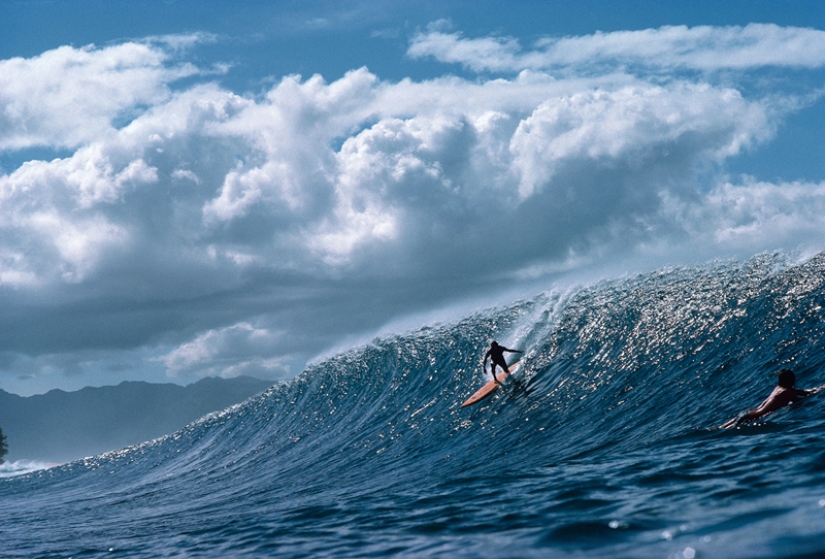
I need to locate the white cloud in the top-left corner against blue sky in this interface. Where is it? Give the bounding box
[0,42,197,150]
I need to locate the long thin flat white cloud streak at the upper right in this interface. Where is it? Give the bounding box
[407,23,825,72]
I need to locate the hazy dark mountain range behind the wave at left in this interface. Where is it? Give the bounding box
[0,377,273,462]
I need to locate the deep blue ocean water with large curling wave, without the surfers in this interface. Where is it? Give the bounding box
[0,254,825,559]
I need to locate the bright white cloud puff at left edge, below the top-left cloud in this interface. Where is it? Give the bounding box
[0,144,150,285]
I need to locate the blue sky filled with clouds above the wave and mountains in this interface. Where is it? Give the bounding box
[0,0,825,395]
